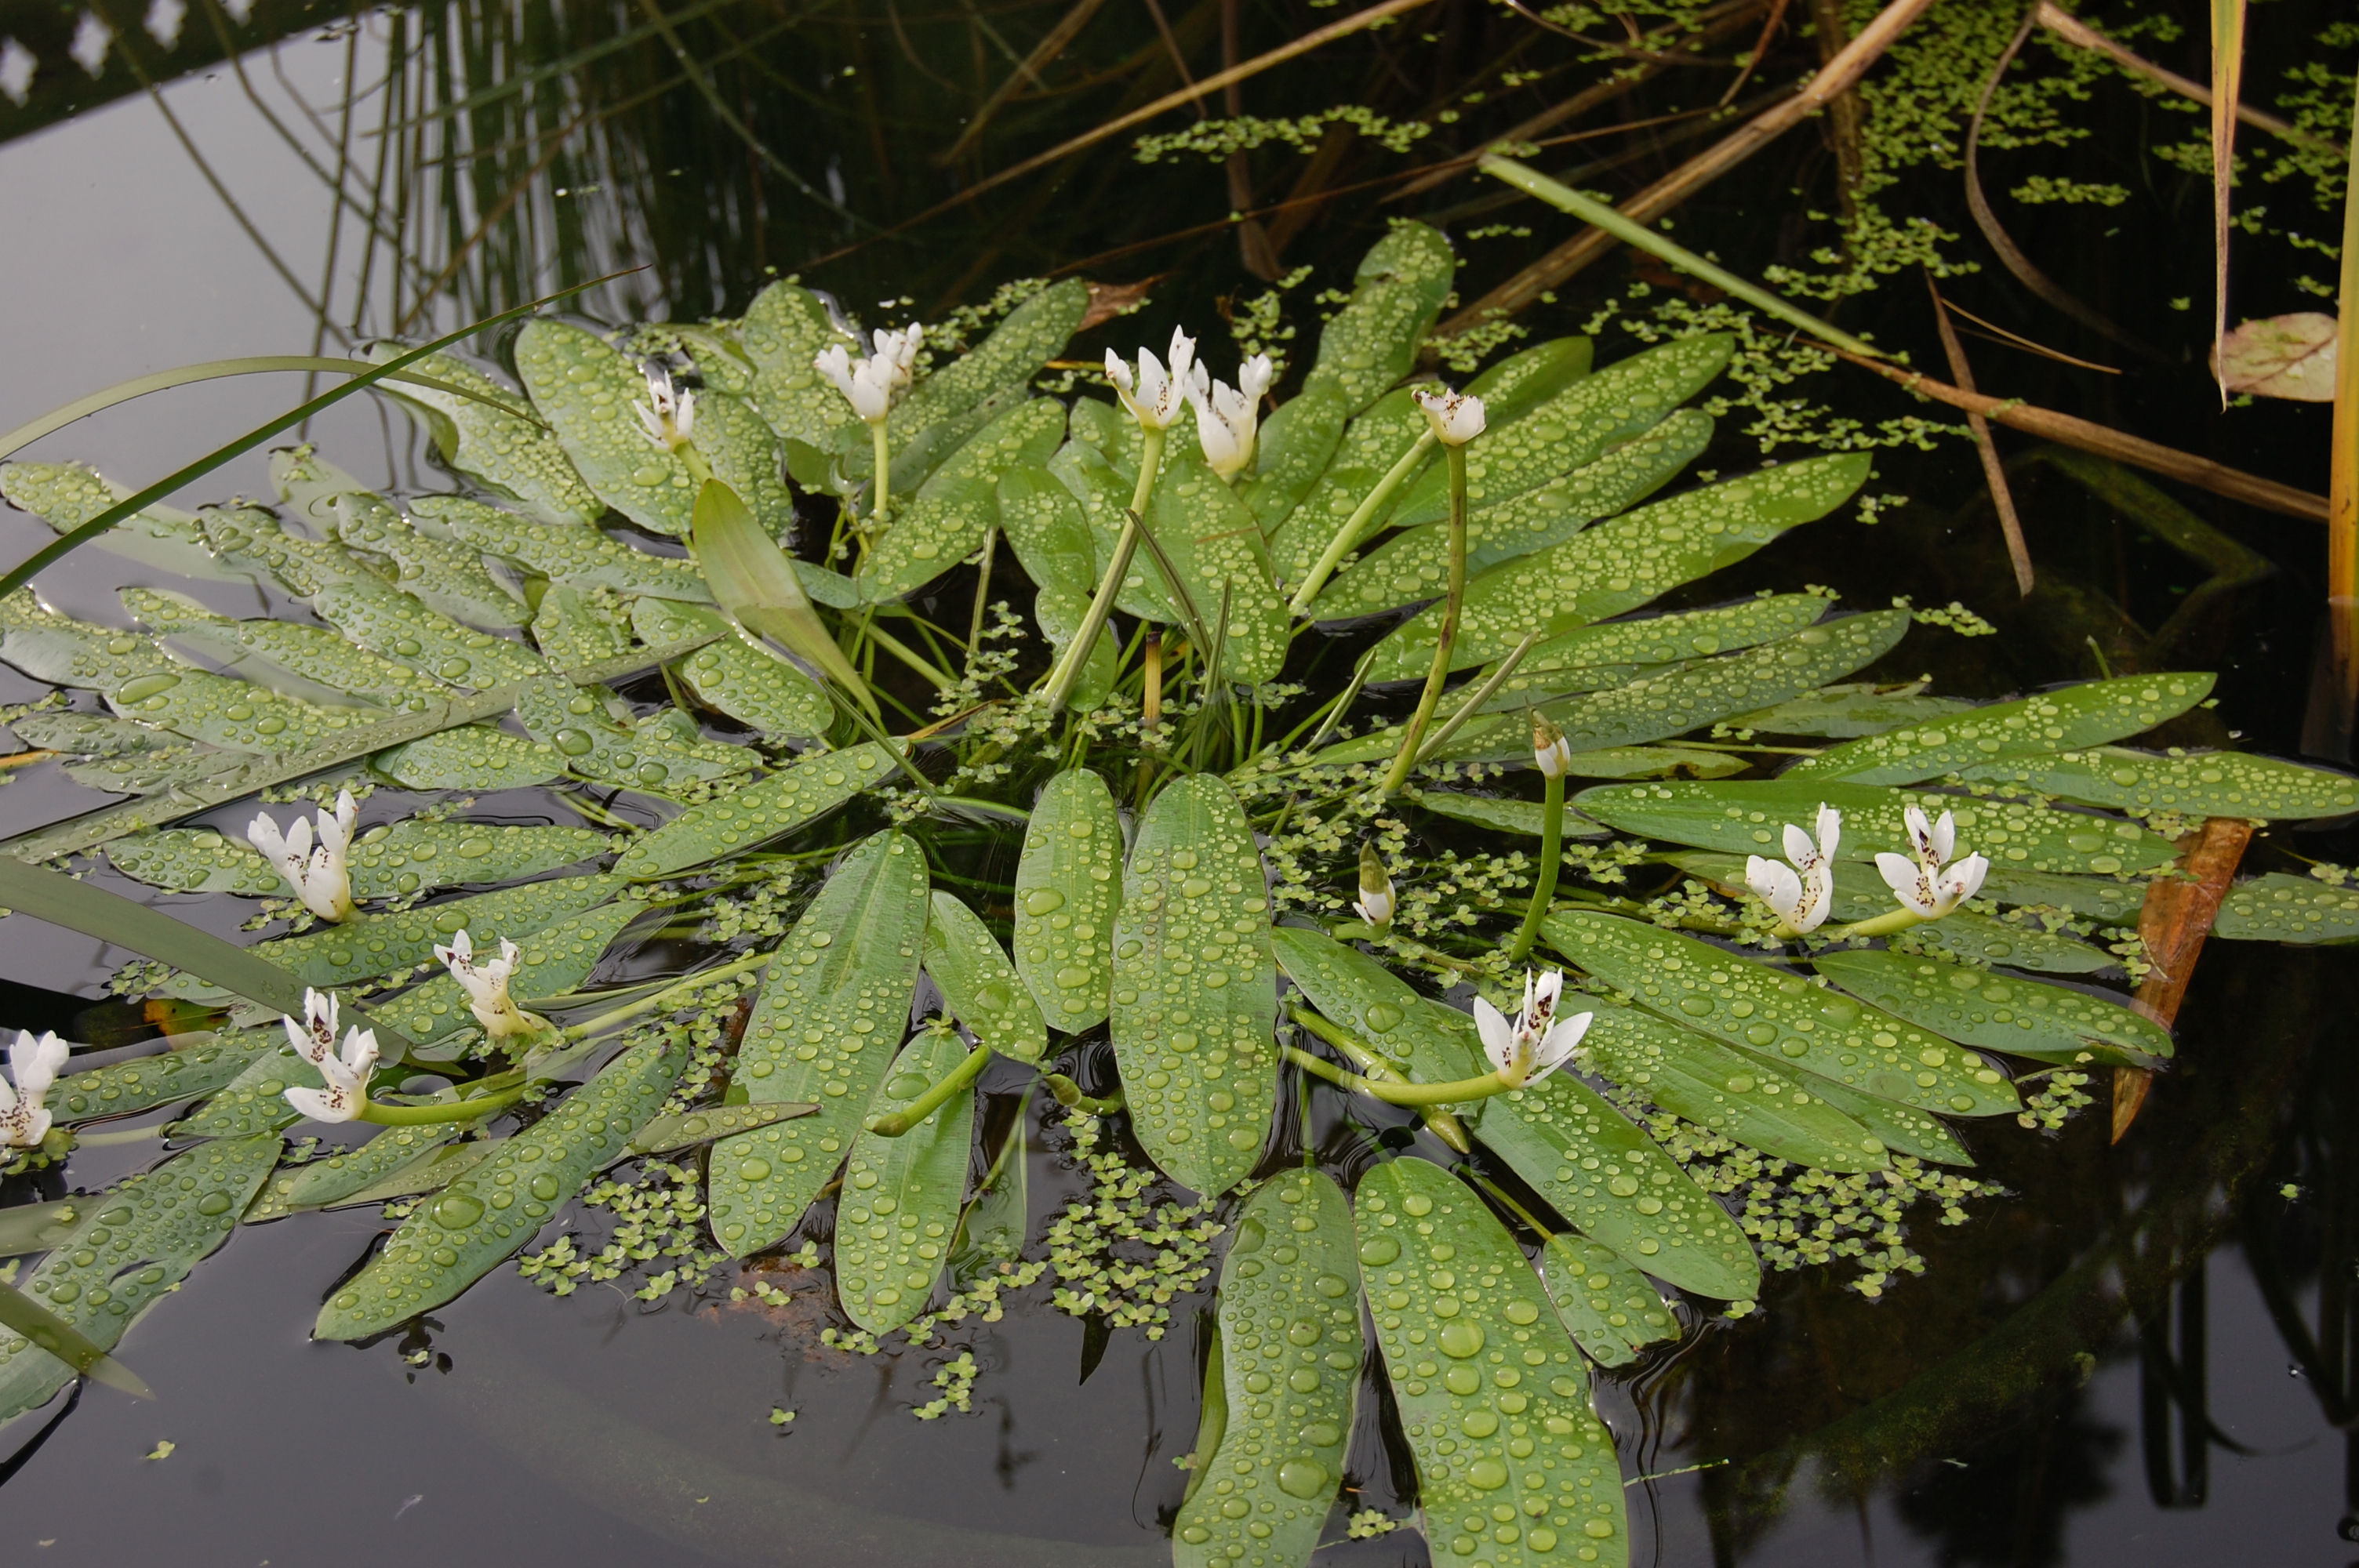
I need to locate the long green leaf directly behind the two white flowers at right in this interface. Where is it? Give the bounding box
[1573,778,2177,891]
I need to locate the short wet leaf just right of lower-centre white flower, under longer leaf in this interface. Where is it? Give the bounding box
[1580,1002,1892,1172]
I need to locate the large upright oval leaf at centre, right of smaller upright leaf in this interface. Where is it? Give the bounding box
[1111,773,1278,1196]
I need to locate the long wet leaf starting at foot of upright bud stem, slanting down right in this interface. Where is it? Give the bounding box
[1543,910,2019,1117]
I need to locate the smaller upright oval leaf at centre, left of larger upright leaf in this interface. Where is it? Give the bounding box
[1014,768,1123,1035]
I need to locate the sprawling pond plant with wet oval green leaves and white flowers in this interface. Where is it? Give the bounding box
[0,224,2359,1568]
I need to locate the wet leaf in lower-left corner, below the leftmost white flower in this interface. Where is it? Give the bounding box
[0,1139,278,1420]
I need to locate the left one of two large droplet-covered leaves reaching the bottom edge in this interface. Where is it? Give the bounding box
[1172,1170,1366,1568]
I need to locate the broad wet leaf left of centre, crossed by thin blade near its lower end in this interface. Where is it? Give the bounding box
[710,830,929,1257]
